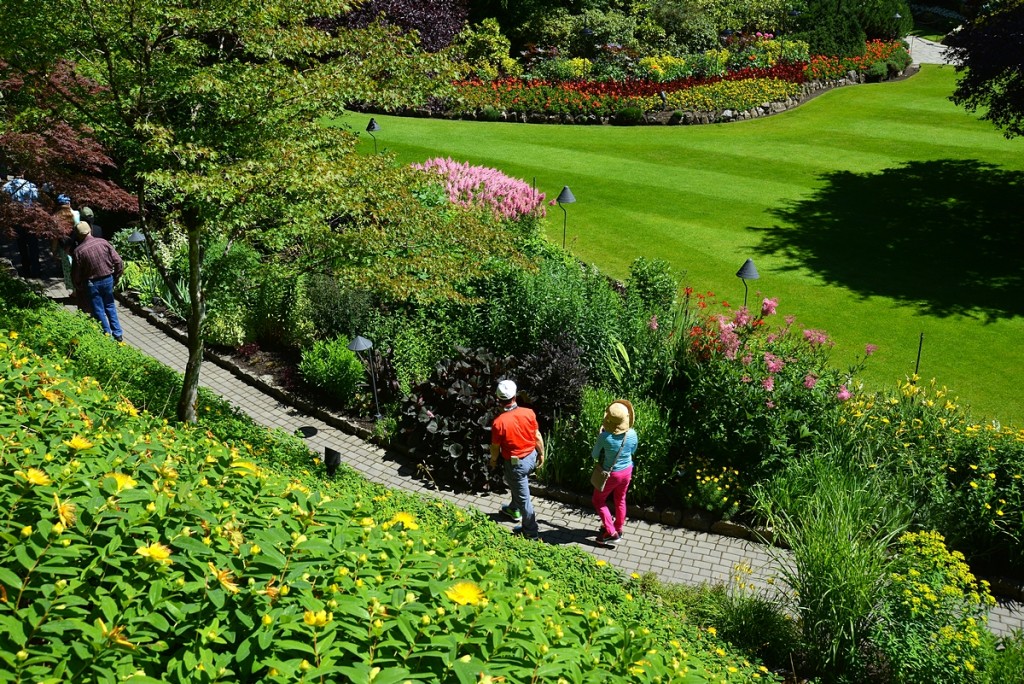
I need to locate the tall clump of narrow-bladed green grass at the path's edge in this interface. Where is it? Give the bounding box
[754,455,909,682]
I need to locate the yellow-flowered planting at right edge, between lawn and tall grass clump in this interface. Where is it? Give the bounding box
[843,378,1024,571]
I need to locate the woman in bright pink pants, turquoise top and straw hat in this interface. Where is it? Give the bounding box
[591,399,638,548]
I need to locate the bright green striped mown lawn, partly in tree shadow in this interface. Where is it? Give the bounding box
[351,67,1024,425]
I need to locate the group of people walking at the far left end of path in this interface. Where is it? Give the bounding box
[0,173,124,342]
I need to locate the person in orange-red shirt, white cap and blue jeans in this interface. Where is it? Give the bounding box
[490,380,544,540]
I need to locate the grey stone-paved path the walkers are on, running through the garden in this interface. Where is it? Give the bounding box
[16,268,1024,634]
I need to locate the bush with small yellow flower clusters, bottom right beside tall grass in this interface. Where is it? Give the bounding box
[870,531,1001,684]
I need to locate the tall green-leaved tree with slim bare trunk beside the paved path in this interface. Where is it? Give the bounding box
[0,0,444,421]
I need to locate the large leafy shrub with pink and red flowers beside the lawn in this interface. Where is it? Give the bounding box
[664,292,874,483]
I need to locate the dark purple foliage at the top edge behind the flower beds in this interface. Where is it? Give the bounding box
[315,0,469,52]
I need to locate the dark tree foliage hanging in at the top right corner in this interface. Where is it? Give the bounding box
[946,0,1024,138]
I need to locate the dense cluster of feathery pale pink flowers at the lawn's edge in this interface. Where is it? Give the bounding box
[413,158,547,221]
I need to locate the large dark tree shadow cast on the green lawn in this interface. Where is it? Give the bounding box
[749,160,1024,322]
